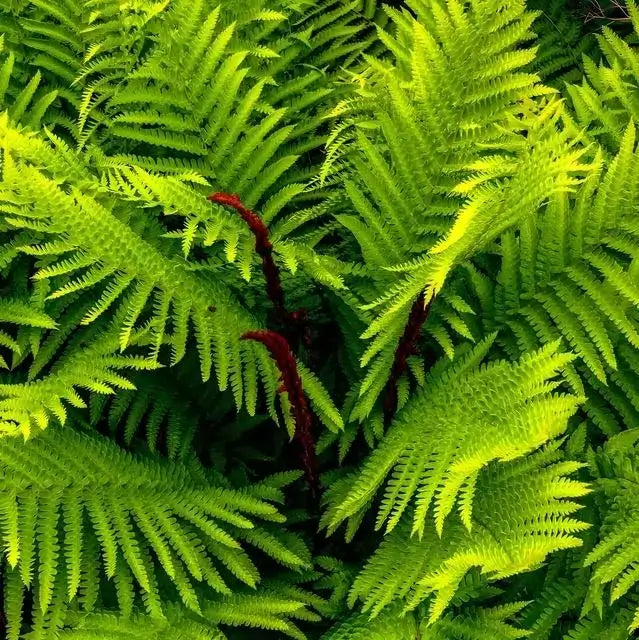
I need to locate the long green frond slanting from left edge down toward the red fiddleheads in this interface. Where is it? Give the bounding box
[2,120,292,418]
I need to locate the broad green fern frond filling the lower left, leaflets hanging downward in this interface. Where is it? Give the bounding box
[0,429,306,612]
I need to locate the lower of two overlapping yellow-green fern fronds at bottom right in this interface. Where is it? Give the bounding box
[349,448,589,623]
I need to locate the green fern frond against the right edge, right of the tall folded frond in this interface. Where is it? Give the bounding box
[476,125,637,420]
